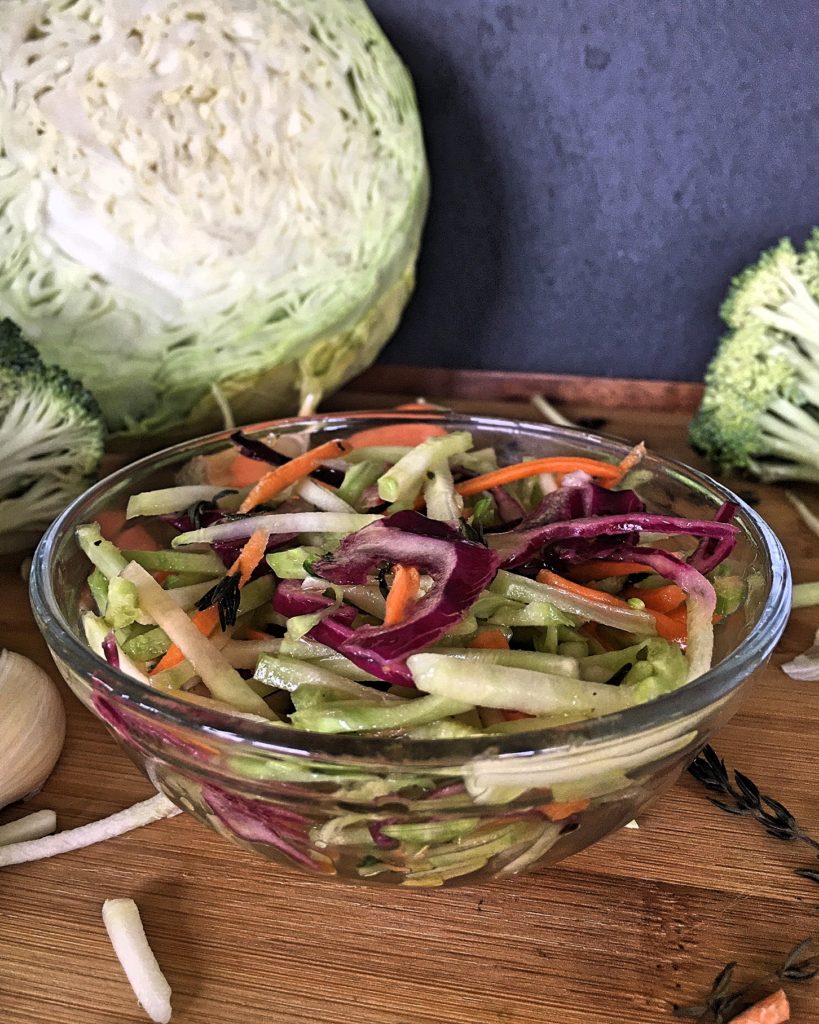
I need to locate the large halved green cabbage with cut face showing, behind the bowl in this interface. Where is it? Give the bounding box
[0,0,428,439]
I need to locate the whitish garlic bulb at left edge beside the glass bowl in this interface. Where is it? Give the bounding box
[0,650,66,808]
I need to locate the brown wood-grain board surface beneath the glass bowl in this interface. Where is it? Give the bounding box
[0,378,819,1024]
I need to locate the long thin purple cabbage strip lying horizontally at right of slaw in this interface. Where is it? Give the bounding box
[489,509,736,568]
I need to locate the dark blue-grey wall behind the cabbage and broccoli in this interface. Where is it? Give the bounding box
[371,0,819,380]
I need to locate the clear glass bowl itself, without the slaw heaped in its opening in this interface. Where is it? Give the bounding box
[31,413,790,887]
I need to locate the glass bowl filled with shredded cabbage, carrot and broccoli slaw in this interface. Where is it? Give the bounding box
[32,410,789,887]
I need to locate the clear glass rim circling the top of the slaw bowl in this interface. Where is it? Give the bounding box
[30,407,790,764]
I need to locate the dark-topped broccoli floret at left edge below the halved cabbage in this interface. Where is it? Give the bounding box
[0,321,105,551]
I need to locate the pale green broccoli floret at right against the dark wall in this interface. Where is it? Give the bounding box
[690,231,819,481]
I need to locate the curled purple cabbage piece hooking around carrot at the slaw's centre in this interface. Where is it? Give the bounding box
[312,512,500,682]
